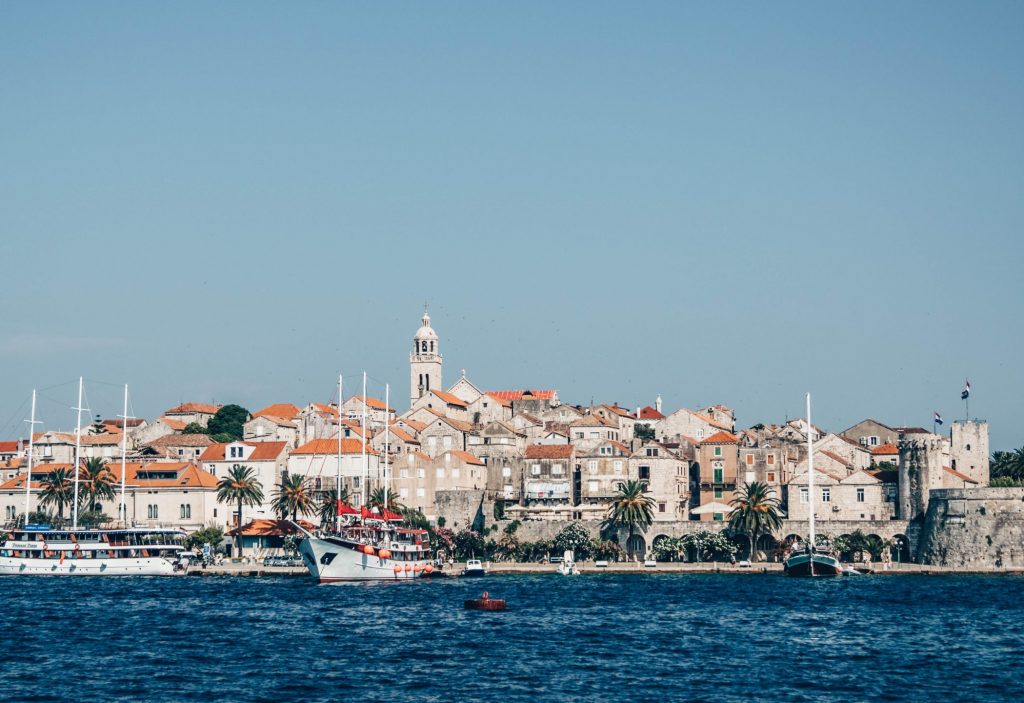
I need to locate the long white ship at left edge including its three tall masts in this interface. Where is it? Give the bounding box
[0,379,187,576]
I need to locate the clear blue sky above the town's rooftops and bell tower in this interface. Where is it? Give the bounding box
[0,1,1024,449]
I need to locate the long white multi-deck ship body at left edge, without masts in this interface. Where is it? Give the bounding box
[0,525,190,576]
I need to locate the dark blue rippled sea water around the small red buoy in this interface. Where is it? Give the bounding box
[0,574,1024,703]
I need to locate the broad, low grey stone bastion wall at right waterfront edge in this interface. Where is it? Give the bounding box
[916,488,1024,569]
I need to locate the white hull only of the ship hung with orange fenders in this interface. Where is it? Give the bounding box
[299,537,433,583]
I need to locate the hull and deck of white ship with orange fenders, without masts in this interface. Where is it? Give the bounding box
[299,520,435,583]
